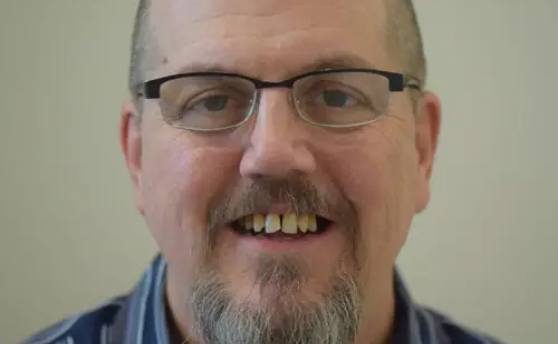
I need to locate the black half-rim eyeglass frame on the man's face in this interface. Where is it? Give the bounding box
[138,68,422,132]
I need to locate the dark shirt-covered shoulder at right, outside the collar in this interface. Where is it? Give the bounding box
[417,307,503,344]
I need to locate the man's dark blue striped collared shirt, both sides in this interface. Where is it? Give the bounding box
[23,255,506,344]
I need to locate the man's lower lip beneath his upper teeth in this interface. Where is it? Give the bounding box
[226,223,336,251]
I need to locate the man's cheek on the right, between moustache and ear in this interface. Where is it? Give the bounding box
[324,130,418,266]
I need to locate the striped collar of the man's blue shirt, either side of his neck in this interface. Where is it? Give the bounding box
[127,255,430,344]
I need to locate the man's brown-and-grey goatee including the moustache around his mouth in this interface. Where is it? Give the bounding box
[188,176,360,344]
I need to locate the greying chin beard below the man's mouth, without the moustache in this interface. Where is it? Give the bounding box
[190,256,360,344]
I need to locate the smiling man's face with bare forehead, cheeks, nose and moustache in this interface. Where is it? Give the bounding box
[124,0,437,340]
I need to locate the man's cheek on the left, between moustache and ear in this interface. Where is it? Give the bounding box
[141,129,239,266]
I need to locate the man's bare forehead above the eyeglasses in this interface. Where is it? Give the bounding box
[151,0,393,80]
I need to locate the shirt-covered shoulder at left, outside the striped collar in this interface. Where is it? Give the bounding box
[21,296,127,344]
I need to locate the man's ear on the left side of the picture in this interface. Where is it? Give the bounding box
[120,101,144,215]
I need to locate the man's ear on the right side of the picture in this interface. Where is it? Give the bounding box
[415,92,441,213]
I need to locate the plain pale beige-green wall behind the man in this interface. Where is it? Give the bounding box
[0,0,558,343]
